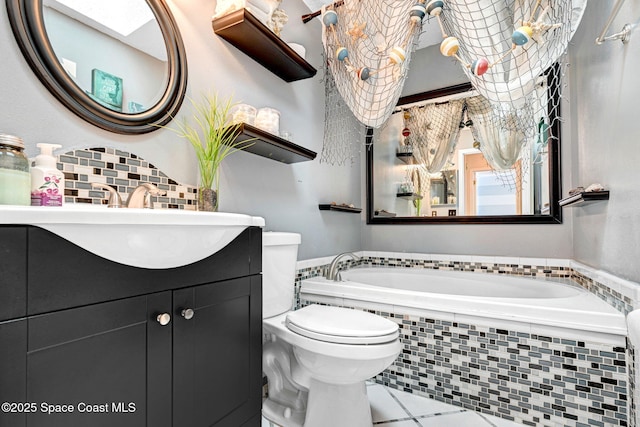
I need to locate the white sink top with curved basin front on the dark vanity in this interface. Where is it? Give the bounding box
[0,205,264,268]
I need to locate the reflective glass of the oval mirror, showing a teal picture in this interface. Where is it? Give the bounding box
[43,0,169,114]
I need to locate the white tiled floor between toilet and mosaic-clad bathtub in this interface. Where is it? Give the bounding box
[262,383,519,427]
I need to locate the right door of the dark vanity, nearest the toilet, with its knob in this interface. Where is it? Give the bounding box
[173,276,262,427]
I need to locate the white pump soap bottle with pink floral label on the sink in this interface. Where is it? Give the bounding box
[31,143,64,206]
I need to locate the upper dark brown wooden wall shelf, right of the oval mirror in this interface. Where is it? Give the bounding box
[212,9,317,82]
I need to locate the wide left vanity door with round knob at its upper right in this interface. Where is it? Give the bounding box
[26,292,172,427]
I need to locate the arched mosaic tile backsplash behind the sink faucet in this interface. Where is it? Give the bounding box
[56,147,198,210]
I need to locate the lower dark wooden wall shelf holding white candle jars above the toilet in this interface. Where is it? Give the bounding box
[236,123,317,163]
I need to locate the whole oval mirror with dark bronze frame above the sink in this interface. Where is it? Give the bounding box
[6,0,187,134]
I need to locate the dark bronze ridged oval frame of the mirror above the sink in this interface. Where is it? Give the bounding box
[6,0,187,134]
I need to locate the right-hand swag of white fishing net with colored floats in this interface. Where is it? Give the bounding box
[427,0,586,108]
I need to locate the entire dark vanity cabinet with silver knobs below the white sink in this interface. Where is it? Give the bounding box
[0,226,262,427]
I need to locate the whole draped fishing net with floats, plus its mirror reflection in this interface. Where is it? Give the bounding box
[322,0,586,171]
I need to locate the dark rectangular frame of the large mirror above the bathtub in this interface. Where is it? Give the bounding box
[365,65,562,225]
